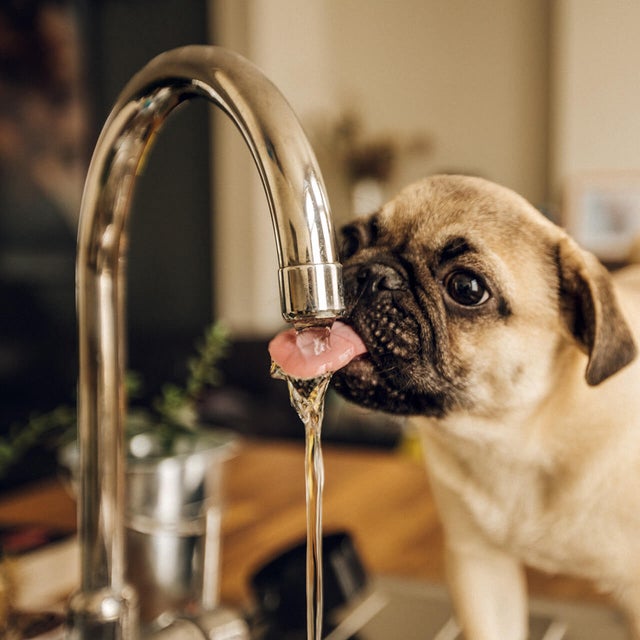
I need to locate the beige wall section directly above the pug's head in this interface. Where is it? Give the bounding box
[327,0,548,203]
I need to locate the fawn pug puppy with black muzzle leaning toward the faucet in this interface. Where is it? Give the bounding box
[334,176,640,640]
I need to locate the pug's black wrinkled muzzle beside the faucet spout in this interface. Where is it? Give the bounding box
[333,256,456,415]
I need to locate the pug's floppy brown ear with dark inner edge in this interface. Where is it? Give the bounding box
[558,237,637,385]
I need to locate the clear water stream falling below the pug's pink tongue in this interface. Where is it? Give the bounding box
[271,363,331,640]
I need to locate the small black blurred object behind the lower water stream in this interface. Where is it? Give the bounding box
[251,532,367,640]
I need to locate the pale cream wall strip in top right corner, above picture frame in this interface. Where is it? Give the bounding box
[550,0,640,198]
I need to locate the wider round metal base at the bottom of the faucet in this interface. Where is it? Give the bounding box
[66,587,139,640]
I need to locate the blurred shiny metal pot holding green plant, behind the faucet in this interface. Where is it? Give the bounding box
[61,428,237,627]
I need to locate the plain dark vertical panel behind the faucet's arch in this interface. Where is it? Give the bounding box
[74,0,215,362]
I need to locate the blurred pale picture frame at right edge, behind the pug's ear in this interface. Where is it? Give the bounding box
[561,170,640,264]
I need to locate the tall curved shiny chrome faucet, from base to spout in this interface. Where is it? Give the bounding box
[67,46,343,640]
